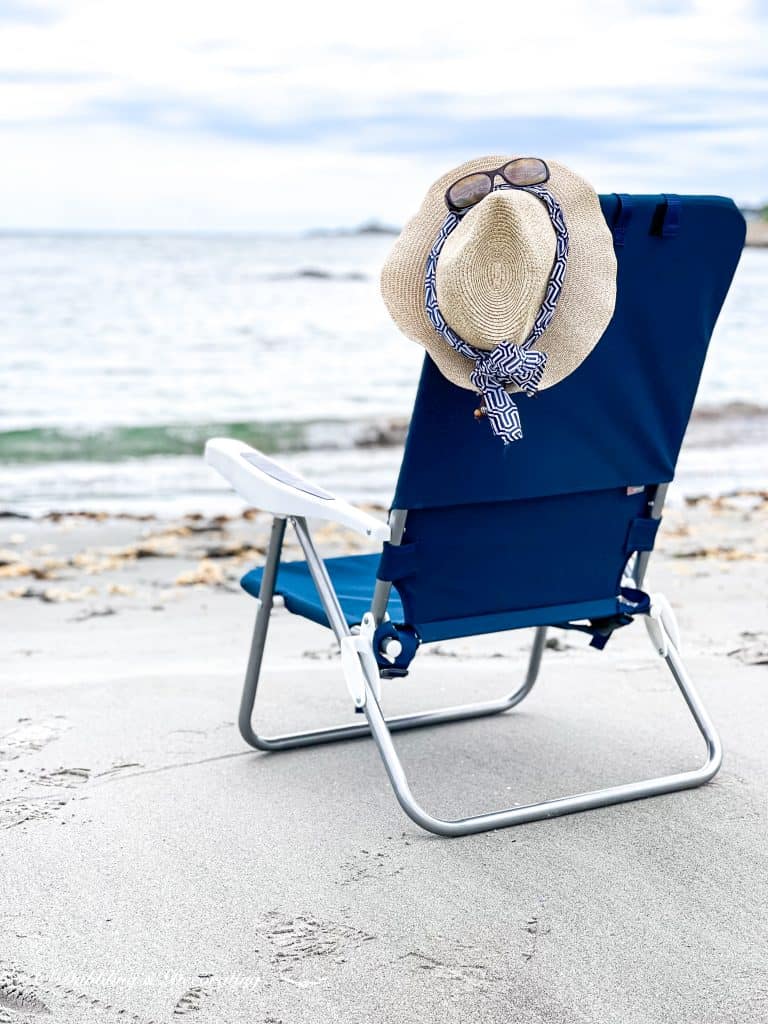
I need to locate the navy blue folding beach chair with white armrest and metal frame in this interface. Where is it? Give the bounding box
[206,195,744,836]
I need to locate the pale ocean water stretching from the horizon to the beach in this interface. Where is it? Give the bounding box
[0,232,768,515]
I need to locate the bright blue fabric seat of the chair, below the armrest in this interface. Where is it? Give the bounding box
[240,555,403,628]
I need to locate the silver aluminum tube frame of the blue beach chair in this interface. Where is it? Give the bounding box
[239,499,722,837]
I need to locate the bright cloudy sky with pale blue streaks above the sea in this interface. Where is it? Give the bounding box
[0,0,768,231]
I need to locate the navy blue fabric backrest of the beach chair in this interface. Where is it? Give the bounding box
[379,196,744,639]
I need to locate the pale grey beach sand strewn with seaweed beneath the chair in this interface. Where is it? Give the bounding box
[0,493,768,1024]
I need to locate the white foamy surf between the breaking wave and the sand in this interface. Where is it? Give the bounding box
[0,402,768,519]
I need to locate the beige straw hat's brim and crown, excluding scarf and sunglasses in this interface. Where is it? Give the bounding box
[381,156,616,391]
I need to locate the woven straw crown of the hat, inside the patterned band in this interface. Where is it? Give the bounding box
[436,189,556,349]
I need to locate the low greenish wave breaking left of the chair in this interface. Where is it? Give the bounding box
[0,419,408,465]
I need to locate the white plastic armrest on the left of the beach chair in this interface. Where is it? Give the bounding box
[205,437,390,541]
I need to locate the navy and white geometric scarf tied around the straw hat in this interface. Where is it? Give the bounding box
[424,184,568,444]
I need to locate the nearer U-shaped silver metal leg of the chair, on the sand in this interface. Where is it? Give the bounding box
[366,626,723,836]
